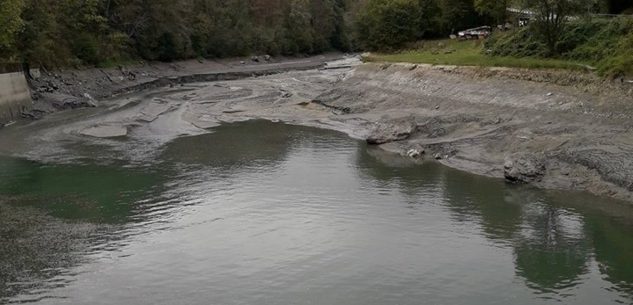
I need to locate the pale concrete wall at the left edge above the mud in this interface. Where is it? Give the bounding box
[0,72,32,126]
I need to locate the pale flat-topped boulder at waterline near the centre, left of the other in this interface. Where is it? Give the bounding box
[367,117,417,145]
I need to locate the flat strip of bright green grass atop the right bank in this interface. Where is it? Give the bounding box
[364,40,587,70]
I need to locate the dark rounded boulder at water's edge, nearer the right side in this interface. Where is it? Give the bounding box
[503,153,545,183]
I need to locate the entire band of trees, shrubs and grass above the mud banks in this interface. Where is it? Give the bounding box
[0,0,633,76]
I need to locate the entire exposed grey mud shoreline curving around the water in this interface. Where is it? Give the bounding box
[0,54,633,202]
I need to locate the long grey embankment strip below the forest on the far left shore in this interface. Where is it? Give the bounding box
[24,53,342,118]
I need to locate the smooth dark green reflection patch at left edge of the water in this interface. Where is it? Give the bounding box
[0,158,162,223]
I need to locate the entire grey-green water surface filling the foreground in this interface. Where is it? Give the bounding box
[0,122,633,305]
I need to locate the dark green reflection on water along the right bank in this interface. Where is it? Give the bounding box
[358,147,633,302]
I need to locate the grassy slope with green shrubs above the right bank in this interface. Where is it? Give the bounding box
[365,18,633,78]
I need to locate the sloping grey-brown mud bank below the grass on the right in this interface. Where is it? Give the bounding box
[318,64,633,200]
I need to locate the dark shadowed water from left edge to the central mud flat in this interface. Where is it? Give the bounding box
[0,121,338,302]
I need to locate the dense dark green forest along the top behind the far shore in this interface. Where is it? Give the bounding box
[0,0,630,67]
